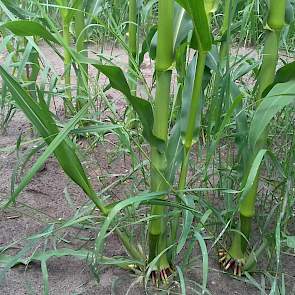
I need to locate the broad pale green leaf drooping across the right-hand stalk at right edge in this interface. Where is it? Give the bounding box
[249,81,295,148]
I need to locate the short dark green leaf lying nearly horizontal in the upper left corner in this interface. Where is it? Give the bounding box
[2,20,59,44]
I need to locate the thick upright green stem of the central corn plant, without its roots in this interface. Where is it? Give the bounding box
[149,0,174,270]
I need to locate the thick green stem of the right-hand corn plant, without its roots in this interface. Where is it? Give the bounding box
[230,0,286,264]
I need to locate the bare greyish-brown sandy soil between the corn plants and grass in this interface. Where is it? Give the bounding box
[0,48,295,295]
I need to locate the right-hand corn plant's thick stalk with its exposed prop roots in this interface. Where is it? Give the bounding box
[219,0,286,276]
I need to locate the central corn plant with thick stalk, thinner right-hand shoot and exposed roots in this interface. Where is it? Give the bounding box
[149,1,216,281]
